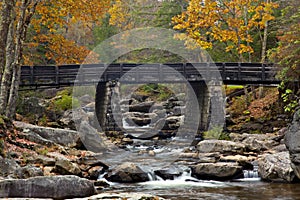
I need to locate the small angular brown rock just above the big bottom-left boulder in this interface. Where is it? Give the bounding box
[54,159,81,175]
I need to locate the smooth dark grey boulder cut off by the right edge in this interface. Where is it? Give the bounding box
[284,109,300,179]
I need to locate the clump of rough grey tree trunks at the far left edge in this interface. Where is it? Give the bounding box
[0,0,40,118]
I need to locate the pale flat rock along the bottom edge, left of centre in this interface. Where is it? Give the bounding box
[69,192,164,200]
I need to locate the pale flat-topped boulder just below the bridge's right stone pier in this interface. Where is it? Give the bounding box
[197,140,245,154]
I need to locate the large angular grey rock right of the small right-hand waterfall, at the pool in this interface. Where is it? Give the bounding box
[258,152,296,183]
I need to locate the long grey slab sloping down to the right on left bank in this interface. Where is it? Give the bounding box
[14,122,82,147]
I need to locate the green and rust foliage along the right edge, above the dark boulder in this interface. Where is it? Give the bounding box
[269,1,300,113]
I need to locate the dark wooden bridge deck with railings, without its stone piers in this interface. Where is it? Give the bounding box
[20,63,280,89]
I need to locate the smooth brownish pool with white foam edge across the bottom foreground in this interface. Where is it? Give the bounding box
[99,175,300,200]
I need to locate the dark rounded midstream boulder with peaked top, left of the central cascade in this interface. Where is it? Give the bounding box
[106,162,149,183]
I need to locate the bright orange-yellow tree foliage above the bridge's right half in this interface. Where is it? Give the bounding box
[173,0,277,61]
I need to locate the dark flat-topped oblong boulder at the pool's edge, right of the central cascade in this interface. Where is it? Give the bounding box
[191,162,243,181]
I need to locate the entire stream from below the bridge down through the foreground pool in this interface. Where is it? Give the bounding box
[95,120,300,200]
